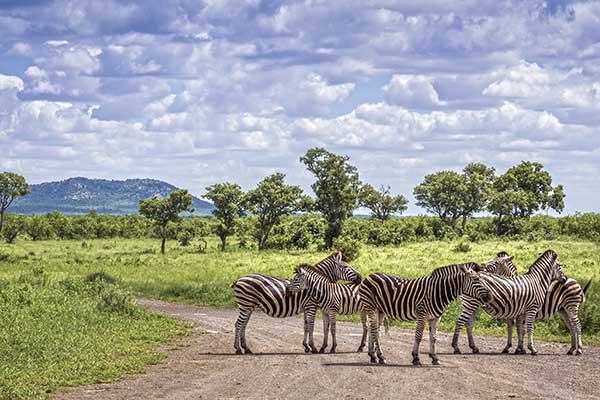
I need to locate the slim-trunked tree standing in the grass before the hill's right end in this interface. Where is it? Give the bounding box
[140,190,194,254]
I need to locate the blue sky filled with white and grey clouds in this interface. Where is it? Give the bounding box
[0,0,600,214]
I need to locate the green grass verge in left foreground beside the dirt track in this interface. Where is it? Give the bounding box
[0,270,188,400]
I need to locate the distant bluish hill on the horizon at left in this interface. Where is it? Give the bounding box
[9,178,214,215]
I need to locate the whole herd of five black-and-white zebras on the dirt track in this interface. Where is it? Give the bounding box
[232,250,591,365]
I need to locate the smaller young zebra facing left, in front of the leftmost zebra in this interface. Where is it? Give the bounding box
[287,264,367,353]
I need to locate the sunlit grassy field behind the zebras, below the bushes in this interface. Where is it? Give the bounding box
[0,234,600,344]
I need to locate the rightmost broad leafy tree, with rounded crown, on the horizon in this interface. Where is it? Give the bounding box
[488,161,565,234]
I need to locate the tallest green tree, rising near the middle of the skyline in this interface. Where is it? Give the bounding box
[300,148,361,248]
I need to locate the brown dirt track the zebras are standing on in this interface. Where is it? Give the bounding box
[56,300,600,400]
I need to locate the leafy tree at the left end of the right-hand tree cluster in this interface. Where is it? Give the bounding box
[413,171,466,228]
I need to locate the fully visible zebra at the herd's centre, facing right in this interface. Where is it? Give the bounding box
[359,263,490,365]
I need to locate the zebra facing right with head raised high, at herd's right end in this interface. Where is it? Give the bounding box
[468,250,567,355]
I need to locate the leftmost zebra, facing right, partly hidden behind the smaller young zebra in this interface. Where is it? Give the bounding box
[231,252,361,354]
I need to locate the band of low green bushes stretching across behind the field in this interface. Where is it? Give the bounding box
[2,211,600,249]
